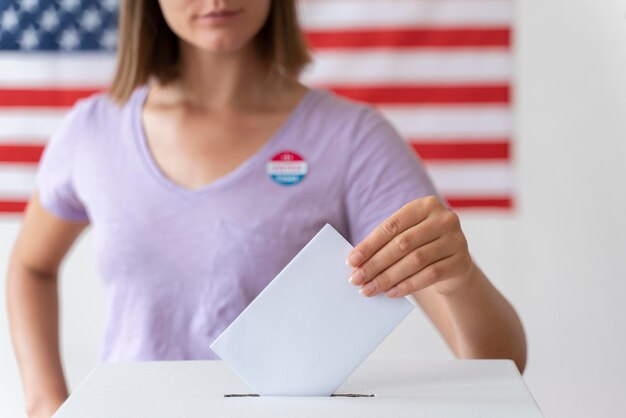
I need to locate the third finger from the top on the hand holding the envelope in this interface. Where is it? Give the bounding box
[359,238,454,296]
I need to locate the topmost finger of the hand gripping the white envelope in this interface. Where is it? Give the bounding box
[346,196,441,267]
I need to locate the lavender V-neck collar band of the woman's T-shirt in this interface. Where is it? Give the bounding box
[131,83,317,199]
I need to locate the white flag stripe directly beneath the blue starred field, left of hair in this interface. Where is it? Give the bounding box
[0,52,115,88]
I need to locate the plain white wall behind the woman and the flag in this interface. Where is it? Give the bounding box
[0,0,626,418]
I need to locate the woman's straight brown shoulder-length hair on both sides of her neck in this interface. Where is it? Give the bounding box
[108,0,311,104]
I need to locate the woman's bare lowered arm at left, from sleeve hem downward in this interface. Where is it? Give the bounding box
[7,194,88,418]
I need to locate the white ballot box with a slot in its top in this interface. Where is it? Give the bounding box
[54,359,542,418]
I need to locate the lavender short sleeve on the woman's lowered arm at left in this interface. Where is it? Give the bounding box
[35,102,89,222]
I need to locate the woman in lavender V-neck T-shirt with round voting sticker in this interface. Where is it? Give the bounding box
[8,0,526,417]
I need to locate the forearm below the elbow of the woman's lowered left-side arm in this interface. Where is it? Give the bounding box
[7,261,68,417]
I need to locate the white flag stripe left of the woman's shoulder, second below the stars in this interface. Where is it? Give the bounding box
[0,108,67,143]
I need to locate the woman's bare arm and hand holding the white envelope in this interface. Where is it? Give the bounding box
[347,196,526,371]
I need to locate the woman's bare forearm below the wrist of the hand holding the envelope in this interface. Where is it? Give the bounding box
[434,264,526,372]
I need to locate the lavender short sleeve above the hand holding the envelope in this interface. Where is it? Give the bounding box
[346,107,445,245]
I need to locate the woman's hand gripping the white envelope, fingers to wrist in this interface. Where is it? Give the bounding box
[346,196,474,297]
